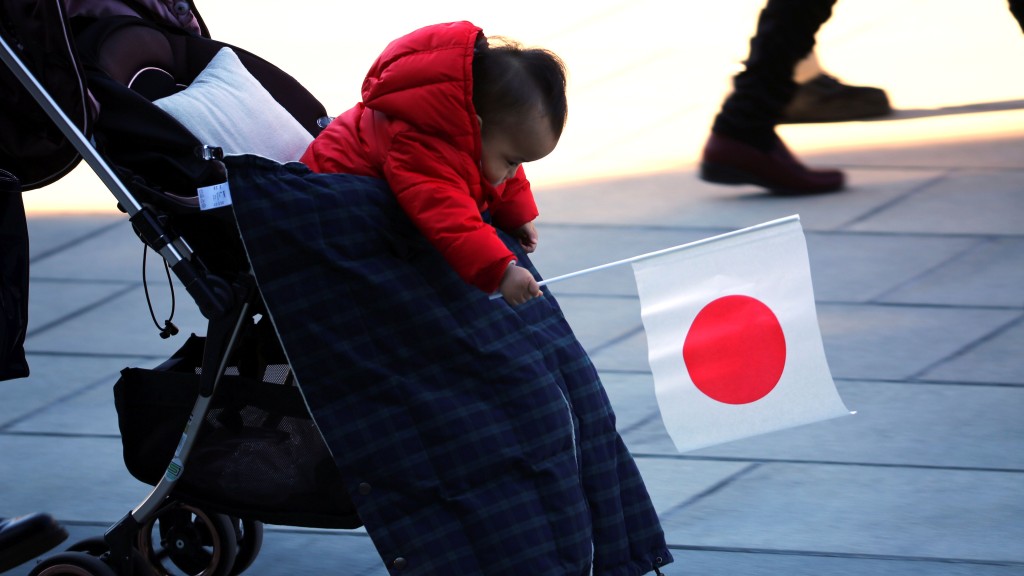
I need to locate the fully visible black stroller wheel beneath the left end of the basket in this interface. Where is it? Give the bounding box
[138,502,239,576]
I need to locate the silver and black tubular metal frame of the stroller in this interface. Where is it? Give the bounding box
[0,1,352,576]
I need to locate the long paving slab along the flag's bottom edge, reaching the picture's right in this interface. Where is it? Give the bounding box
[684,380,1024,472]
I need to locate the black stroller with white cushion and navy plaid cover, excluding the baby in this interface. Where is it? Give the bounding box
[0,0,671,576]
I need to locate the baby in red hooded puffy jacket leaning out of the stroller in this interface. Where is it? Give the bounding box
[302,22,567,304]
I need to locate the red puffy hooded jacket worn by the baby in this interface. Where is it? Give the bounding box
[302,22,538,292]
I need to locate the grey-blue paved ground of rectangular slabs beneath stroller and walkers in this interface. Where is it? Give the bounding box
[0,127,1024,576]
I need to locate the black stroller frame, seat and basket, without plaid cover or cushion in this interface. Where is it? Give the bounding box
[0,0,361,576]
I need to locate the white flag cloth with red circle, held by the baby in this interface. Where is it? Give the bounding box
[632,216,851,452]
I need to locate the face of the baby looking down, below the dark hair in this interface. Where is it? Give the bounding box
[480,114,558,187]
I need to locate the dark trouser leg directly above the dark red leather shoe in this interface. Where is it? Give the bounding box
[712,0,839,150]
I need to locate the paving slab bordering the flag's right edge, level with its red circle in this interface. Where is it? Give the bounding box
[817,303,1020,380]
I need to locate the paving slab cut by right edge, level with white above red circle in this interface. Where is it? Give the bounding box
[879,235,1024,307]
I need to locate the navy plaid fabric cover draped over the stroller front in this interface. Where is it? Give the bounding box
[225,157,671,576]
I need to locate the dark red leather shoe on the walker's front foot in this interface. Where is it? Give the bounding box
[700,134,846,195]
